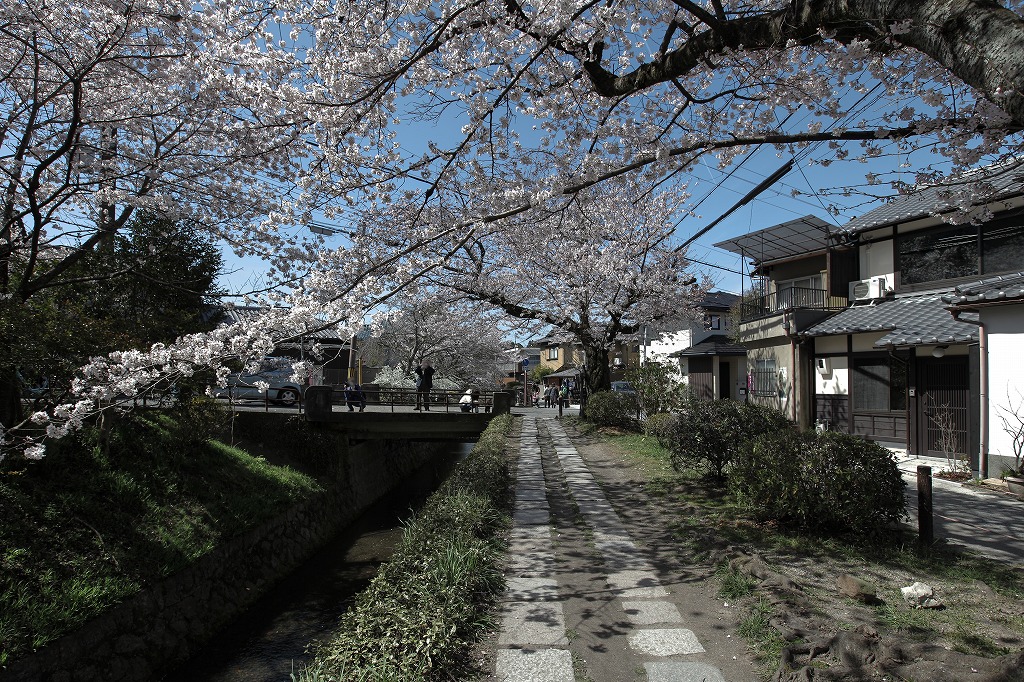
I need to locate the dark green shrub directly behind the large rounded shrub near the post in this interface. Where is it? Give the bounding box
[663,398,791,480]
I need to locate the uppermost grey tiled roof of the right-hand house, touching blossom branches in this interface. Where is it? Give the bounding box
[838,167,1024,235]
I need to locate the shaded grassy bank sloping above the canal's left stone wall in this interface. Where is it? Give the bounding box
[0,402,323,665]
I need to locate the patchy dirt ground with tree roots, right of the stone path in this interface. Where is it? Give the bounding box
[480,419,1024,682]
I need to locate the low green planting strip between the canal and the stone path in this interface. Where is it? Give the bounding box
[293,415,512,682]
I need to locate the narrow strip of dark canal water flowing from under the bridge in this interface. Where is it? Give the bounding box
[164,443,473,682]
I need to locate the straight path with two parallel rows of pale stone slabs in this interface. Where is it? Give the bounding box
[496,416,737,682]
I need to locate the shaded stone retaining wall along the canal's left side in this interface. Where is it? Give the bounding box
[0,414,445,682]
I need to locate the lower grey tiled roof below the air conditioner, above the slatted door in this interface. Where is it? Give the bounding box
[805,294,978,348]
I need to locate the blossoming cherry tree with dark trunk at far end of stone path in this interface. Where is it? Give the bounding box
[403,180,709,391]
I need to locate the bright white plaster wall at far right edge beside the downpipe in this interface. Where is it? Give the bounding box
[981,303,1024,458]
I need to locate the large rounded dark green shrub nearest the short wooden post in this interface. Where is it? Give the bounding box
[729,430,906,536]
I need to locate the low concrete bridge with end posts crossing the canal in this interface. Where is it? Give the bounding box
[304,386,512,440]
